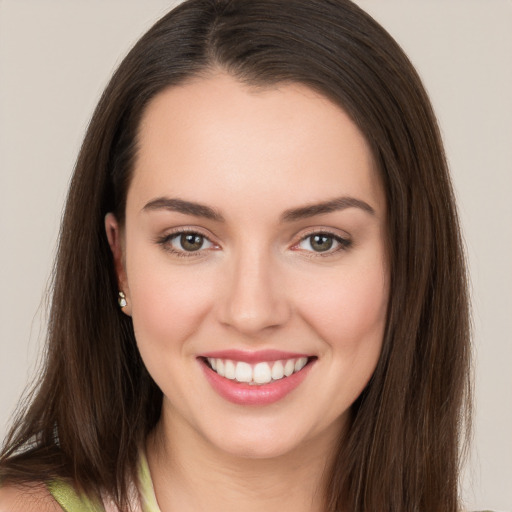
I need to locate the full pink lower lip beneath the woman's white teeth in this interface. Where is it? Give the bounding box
[198,359,315,405]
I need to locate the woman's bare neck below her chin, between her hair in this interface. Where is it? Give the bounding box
[147,406,339,512]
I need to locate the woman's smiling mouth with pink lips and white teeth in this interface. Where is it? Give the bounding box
[198,352,318,405]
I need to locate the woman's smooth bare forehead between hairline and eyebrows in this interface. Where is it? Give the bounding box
[128,74,383,216]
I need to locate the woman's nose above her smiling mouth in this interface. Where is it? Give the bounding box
[218,250,291,336]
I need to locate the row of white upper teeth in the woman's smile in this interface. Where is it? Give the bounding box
[208,357,308,384]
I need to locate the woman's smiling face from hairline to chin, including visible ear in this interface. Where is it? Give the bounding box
[106,74,389,457]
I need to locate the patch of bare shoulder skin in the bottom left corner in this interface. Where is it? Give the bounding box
[0,484,62,512]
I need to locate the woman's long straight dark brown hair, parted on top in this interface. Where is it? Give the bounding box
[0,0,470,512]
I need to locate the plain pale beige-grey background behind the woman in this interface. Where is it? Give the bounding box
[0,0,512,510]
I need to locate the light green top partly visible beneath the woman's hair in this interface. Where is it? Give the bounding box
[46,453,160,512]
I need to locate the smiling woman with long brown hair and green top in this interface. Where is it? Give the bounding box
[0,0,469,512]
